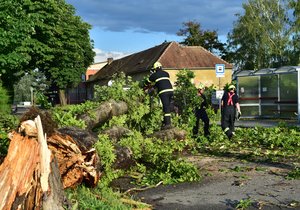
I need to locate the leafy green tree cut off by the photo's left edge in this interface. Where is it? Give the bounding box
[0,0,34,96]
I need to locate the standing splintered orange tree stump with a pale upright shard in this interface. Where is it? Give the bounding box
[0,116,67,210]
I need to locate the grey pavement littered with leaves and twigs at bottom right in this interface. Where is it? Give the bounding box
[132,155,300,210]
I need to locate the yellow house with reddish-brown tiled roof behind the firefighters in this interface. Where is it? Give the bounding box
[87,42,232,97]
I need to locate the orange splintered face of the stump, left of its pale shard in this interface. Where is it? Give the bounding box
[0,132,42,209]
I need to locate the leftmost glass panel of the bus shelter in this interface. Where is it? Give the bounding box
[238,76,259,104]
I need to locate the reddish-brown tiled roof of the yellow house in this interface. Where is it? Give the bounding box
[89,42,232,82]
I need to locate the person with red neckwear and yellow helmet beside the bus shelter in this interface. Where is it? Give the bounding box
[221,85,241,139]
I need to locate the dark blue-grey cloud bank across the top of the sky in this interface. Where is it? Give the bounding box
[67,0,247,35]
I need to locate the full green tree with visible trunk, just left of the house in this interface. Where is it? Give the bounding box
[34,1,95,104]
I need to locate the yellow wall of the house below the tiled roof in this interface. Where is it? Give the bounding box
[165,69,232,89]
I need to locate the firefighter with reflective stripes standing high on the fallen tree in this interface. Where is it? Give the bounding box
[148,62,173,129]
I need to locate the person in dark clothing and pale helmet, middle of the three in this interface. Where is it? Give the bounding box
[193,83,210,137]
